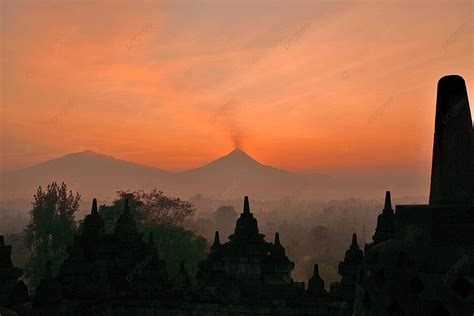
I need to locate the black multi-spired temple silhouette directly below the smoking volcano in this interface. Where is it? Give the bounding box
[198,197,304,301]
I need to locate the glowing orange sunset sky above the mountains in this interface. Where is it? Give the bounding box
[1,0,474,173]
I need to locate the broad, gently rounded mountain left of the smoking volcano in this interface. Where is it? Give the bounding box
[2,150,170,198]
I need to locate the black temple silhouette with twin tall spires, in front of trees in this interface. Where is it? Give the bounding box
[27,199,174,315]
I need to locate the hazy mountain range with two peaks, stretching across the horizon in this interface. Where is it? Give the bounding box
[0,148,426,201]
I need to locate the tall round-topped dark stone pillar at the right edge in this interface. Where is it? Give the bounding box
[430,76,474,205]
